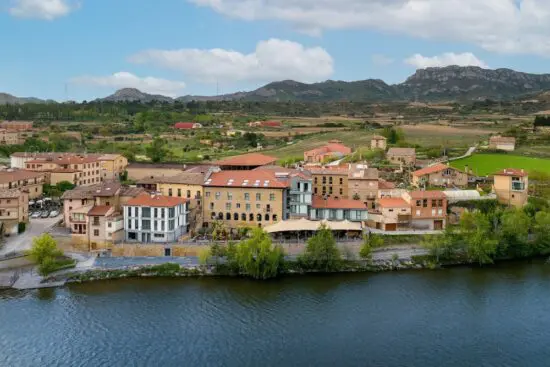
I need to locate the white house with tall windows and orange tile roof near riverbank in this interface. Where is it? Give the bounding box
[123,193,189,243]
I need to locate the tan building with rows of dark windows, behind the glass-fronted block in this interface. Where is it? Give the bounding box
[310,166,349,199]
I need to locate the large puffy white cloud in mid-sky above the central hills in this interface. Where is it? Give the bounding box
[130,39,334,82]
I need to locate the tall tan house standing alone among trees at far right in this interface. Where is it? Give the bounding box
[493,168,529,208]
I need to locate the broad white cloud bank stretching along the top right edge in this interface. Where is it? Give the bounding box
[188,0,550,56]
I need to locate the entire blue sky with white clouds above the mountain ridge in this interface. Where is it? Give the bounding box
[0,0,550,101]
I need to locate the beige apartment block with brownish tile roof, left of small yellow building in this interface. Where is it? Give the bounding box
[25,154,102,186]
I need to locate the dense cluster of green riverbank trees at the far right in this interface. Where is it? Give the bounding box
[424,204,550,265]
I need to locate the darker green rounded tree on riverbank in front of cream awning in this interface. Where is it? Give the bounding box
[302,224,340,271]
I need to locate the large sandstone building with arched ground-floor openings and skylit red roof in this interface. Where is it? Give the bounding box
[203,170,290,228]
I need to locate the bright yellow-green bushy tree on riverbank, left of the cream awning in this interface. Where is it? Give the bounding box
[235,228,284,279]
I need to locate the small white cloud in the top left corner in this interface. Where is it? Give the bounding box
[9,0,77,20]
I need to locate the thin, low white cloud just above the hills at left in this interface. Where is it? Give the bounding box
[71,71,185,97]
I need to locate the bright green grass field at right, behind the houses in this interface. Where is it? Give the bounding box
[451,154,550,176]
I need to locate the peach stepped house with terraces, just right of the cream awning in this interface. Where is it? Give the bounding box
[367,198,411,232]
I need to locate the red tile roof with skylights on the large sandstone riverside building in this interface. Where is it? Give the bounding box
[204,169,290,189]
